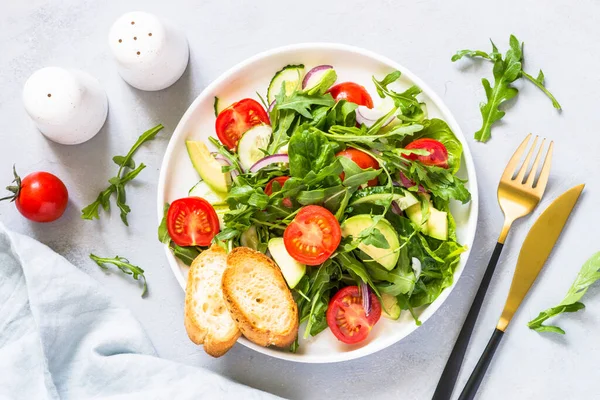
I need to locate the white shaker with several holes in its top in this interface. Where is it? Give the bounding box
[108,11,190,90]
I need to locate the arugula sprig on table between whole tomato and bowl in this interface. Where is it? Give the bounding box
[81,124,164,226]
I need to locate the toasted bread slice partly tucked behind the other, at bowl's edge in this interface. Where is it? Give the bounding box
[184,245,241,357]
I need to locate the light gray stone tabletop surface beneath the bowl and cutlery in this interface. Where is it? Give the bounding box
[0,0,600,399]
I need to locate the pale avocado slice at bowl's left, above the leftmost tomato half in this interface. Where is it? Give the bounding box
[185,140,231,193]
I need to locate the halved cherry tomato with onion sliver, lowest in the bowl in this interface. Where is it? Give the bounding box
[326,286,381,344]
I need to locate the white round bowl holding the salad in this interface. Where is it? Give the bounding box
[157,43,478,363]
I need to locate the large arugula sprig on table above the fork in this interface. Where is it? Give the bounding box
[452,35,561,142]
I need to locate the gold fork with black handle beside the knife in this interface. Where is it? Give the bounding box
[432,134,554,400]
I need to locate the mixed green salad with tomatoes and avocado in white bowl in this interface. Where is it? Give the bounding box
[160,65,471,350]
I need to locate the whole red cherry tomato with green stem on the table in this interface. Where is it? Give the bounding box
[0,171,69,222]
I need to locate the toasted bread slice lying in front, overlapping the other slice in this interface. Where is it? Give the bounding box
[223,247,298,347]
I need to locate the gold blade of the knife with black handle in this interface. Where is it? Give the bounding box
[496,184,585,332]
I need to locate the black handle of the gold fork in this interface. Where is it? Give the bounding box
[432,242,504,400]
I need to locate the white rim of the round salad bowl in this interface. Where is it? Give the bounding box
[157,42,479,364]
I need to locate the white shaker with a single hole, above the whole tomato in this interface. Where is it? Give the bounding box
[23,67,108,144]
